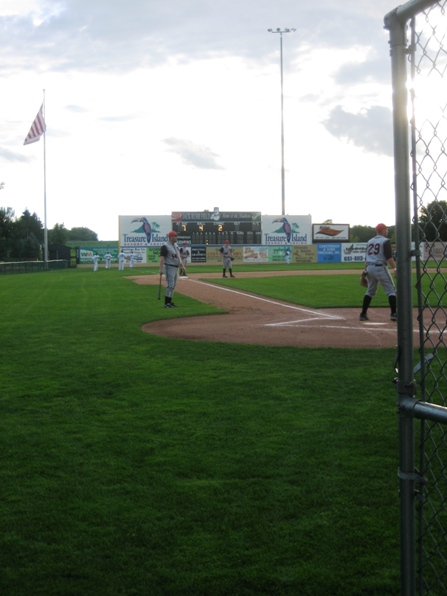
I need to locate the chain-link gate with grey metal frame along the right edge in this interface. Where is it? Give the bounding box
[385,0,447,596]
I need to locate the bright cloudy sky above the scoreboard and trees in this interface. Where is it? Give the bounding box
[0,0,399,240]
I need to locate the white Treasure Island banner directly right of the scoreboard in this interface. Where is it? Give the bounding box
[261,215,312,245]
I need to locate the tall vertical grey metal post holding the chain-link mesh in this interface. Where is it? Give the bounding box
[385,9,416,596]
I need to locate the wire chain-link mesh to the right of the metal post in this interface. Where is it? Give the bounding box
[409,0,447,594]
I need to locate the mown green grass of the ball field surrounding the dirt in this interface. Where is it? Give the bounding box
[0,266,400,596]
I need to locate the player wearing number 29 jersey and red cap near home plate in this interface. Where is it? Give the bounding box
[360,224,397,321]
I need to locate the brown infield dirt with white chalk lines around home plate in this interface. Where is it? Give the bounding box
[133,271,406,348]
